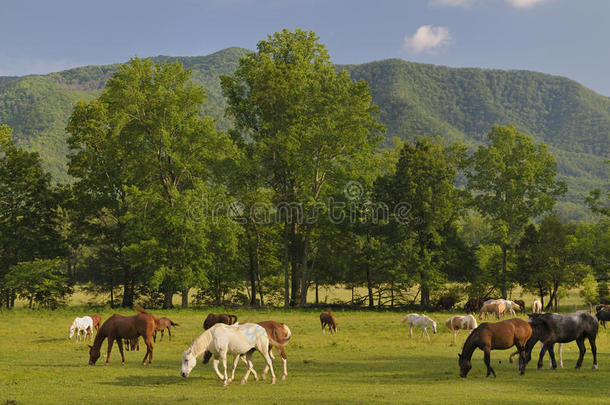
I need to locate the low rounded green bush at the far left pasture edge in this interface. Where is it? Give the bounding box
[5,259,72,309]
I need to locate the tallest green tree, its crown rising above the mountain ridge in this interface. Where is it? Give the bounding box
[221,30,382,306]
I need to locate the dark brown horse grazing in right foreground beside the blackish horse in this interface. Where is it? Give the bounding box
[458,318,532,377]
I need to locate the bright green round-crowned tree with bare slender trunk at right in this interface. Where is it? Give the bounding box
[466,126,566,298]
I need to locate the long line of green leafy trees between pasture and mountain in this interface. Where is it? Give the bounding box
[0,30,610,308]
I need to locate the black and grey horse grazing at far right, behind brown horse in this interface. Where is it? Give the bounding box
[527,312,599,370]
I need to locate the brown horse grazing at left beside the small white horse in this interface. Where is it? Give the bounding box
[89,307,156,366]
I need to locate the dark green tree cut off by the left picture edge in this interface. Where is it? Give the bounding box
[0,125,65,308]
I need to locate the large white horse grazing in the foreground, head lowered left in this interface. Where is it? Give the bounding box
[180,323,277,386]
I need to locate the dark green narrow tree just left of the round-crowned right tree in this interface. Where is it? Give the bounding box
[376,138,465,307]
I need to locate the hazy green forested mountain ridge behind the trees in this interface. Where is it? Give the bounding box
[0,48,610,219]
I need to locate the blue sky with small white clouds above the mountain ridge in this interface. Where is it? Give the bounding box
[0,0,610,96]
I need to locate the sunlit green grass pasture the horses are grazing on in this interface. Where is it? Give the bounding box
[0,307,610,404]
